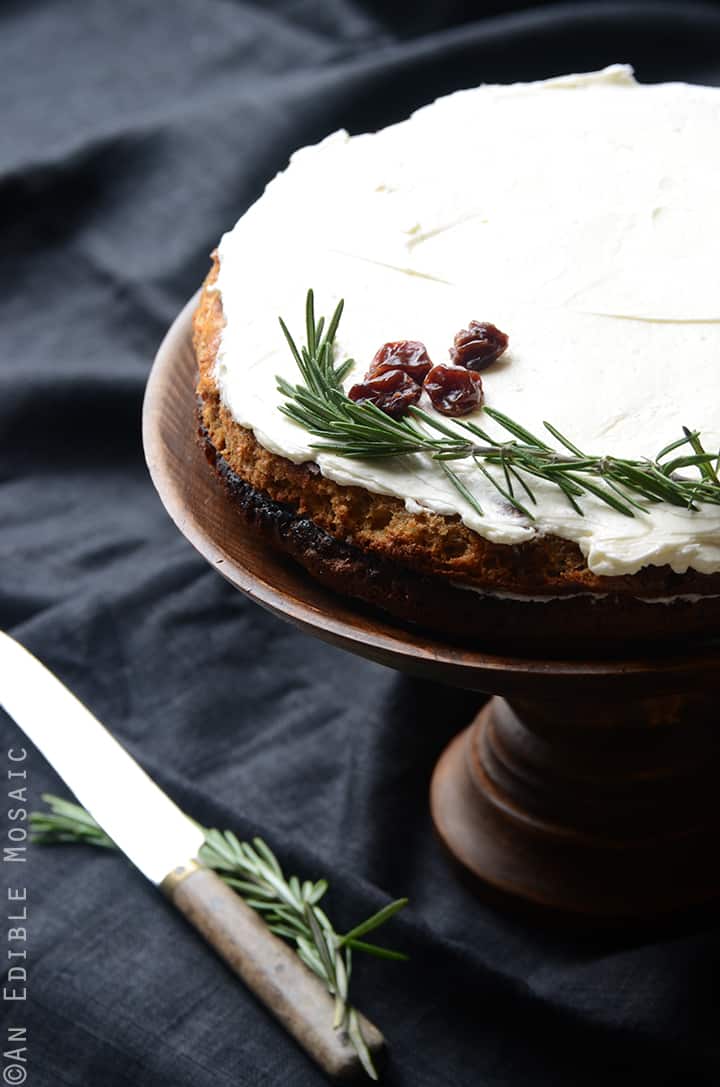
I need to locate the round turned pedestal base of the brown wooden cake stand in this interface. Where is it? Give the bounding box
[431,694,720,920]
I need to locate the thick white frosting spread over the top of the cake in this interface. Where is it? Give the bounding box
[215,65,720,575]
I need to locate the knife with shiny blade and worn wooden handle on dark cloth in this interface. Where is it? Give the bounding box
[0,630,384,1082]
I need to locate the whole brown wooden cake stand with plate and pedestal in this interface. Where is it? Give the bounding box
[144,299,720,919]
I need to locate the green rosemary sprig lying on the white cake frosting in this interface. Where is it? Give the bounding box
[277,290,720,520]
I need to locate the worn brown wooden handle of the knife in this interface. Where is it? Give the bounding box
[163,867,385,1083]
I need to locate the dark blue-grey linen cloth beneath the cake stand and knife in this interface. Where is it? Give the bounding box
[0,0,720,1087]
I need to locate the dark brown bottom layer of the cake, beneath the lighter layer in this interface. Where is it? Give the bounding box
[200,412,720,657]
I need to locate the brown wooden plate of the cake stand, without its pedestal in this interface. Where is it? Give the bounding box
[142,292,720,695]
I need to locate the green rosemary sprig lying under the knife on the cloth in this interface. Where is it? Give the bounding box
[30,794,408,1079]
